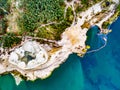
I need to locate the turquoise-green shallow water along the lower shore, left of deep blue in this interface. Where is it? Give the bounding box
[0,54,84,90]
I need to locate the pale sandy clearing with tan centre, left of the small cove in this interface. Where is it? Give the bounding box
[59,20,88,55]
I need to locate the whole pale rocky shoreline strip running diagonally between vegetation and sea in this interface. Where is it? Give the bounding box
[0,2,117,84]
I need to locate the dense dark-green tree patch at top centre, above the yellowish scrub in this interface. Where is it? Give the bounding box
[18,0,64,32]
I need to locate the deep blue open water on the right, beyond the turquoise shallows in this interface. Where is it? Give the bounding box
[81,17,120,90]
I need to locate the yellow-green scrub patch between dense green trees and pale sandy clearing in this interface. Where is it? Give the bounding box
[37,8,74,40]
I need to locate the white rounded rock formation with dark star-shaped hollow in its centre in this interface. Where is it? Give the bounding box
[8,41,48,69]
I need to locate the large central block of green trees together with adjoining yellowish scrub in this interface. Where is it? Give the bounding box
[17,0,74,40]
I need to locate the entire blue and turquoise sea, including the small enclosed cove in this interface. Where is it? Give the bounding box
[0,18,120,90]
